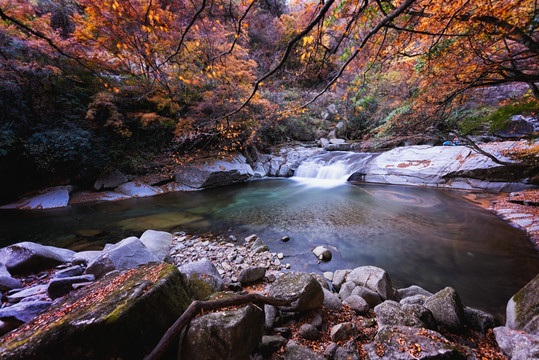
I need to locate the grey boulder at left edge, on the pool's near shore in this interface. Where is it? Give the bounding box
[0,241,75,274]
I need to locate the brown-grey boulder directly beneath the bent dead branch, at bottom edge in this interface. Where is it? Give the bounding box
[180,305,264,360]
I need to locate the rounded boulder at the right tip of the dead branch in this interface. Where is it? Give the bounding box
[268,271,324,311]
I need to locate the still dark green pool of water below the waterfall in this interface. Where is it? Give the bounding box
[0,179,539,318]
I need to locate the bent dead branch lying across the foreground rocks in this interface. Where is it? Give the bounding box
[144,294,299,360]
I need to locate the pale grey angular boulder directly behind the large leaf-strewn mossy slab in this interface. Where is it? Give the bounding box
[86,236,159,279]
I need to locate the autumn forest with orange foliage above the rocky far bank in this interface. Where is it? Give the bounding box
[0,0,539,202]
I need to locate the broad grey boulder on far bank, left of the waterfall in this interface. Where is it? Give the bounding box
[174,155,254,189]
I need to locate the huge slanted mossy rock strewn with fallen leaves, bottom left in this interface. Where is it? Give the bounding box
[0,263,191,360]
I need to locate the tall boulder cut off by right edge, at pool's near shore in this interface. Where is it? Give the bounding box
[505,274,539,335]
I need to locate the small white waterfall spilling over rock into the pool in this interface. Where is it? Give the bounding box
[292,151,374,187]
